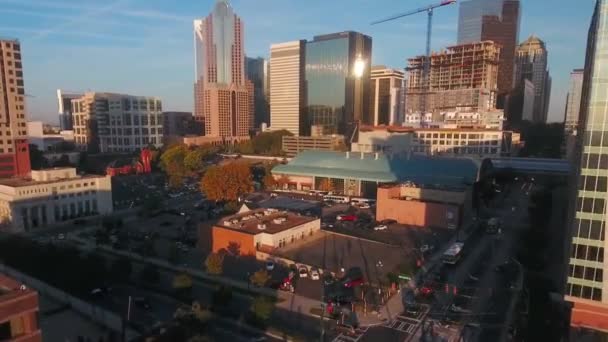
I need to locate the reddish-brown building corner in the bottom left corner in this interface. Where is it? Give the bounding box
[0,274,42,342]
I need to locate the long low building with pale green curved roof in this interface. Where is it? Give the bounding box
[272,151,478,198]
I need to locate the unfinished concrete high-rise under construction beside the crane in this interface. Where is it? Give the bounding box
[406,41,500,113]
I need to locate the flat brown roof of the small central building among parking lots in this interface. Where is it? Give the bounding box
[215,209,318,235]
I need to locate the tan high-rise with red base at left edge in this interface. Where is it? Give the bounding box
[0,39,31,177]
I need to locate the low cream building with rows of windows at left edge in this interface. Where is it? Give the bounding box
[0,168,112,232]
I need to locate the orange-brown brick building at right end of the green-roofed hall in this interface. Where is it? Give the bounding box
[376,183,472,229]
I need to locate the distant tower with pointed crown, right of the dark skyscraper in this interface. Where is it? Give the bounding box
[515,36,551,122]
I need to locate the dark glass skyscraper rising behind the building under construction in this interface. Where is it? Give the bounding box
[458,0,521,94]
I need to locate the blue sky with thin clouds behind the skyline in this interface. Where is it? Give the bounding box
[0,0,595,122]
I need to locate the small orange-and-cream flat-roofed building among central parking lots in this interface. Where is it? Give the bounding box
[211,209,321,255]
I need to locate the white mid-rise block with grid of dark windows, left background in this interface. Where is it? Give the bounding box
[72,93,163,153]
